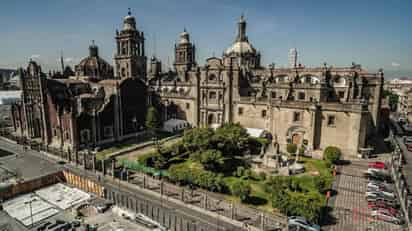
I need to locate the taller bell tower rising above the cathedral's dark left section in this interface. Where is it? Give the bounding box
[114,8,147,80]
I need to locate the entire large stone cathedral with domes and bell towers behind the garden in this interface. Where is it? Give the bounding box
[12,12,384,159]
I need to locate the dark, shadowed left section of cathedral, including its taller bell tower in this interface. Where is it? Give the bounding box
[12,12,150,153]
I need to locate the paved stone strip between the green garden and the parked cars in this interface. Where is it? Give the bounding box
[323,160,404,231]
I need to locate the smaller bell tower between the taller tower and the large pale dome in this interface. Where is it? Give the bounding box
[174,29,196,72]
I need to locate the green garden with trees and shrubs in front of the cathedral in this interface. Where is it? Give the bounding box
[119,124,340,222]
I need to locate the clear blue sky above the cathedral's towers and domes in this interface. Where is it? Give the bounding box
[0,0,412,78]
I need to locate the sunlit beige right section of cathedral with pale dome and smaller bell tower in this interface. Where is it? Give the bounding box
[148,14,384,155]
